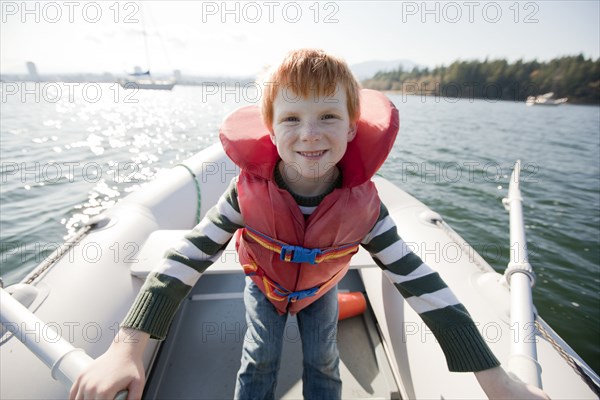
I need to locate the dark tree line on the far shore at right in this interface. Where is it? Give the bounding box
[362,54,600,105]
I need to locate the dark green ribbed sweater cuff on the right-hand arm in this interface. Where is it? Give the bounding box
[435,324,500,372]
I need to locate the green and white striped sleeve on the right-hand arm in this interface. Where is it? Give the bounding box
[362,203,500,372]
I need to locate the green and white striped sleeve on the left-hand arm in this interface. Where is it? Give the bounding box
[121,178,244,340]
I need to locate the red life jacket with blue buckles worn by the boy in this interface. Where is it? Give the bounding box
[220,90,399,314]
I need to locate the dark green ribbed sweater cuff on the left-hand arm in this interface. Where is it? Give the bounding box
[121,292,179,340]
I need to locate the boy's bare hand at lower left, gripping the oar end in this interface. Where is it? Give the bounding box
[69,329,149,400]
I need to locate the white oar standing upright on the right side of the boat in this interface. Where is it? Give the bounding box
[502,160,542,388]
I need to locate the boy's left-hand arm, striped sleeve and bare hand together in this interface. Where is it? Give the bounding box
[69,179,243,399]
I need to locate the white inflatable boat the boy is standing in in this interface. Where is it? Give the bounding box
[0,144,600,399]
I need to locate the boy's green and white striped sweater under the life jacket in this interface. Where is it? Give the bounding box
[122,174,500,371]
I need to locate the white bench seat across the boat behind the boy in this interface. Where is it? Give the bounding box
[130,229,378,279]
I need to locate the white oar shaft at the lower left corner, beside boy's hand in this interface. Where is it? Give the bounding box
[0,288,127,400]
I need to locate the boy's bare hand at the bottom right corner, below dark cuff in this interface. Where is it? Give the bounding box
[475,367,550,400]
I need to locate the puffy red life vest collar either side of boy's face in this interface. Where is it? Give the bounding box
[219,89,400,187]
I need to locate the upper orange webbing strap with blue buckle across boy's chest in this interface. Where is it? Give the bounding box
[243,227,360,264]
